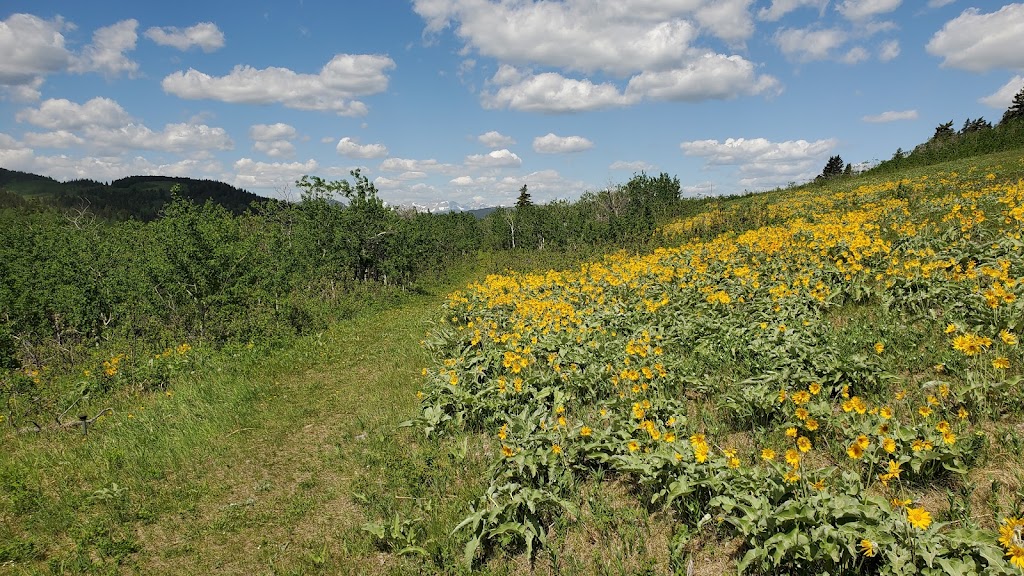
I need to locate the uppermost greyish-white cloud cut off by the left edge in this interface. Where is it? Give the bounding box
[0,14,71,86]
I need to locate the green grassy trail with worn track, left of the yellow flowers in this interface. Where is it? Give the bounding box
[0,296,464,574]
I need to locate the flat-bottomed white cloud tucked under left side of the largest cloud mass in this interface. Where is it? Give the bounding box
[480,71,636,113]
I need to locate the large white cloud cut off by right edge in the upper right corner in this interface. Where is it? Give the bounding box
[926,3,1024,72]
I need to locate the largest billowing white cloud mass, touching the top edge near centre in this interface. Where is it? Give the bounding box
[414,0,778,109]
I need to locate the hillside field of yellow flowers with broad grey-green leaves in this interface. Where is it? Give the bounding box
[417,159,1024,574]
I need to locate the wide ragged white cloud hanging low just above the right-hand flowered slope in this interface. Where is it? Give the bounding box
[680,138,838,188]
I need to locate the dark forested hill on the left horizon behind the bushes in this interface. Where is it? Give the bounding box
[0,168,265,220]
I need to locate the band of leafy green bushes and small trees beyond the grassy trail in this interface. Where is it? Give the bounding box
[0,167,700,369]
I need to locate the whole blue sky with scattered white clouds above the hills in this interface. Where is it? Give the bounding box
[0,0,1024,207]
